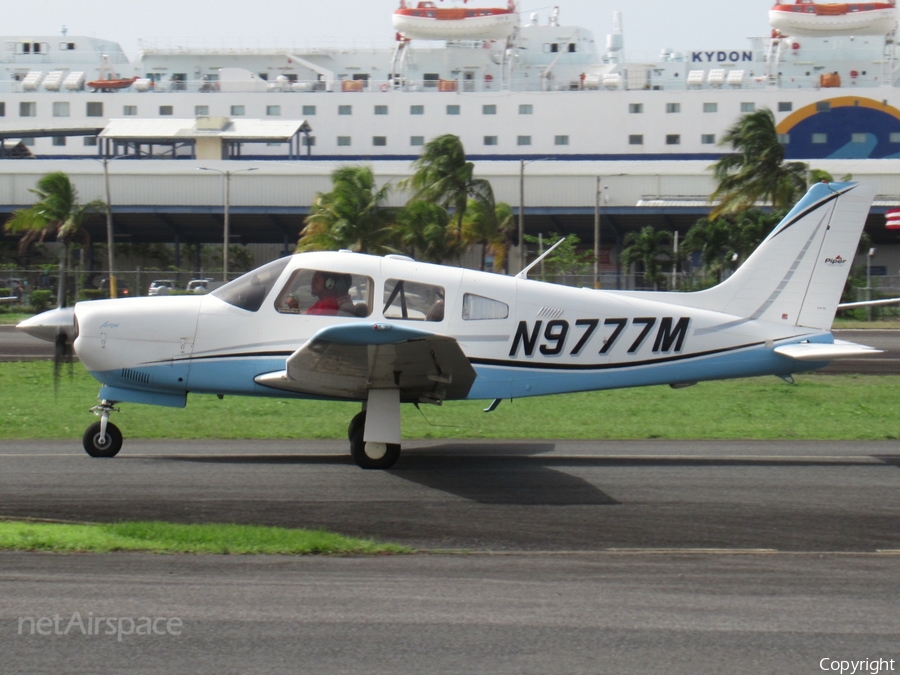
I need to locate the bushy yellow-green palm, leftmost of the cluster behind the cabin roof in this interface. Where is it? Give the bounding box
[297,166,396,254]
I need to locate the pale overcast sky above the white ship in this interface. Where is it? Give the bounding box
[15,0,772,60]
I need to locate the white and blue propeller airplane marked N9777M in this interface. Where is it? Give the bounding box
[19,183,879,469]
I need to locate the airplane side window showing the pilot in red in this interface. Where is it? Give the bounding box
[275,269,375,317]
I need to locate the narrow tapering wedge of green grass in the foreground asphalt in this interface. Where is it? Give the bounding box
[0,521,413,555]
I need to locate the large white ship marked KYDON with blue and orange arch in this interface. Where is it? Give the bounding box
[0,0,900,161]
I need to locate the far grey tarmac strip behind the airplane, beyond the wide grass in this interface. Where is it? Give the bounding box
[0,326,900,375]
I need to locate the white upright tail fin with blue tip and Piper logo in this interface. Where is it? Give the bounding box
[684,183,875,330]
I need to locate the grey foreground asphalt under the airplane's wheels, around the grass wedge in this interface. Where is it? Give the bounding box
[0,441,900,674]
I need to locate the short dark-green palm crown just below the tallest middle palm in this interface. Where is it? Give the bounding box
[397,199,465,263]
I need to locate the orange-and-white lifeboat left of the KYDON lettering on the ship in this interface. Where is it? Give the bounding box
[393,0,519,40]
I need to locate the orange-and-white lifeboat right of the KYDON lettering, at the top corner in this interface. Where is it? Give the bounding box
[769,0,897,37]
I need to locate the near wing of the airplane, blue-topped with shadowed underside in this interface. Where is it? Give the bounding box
[256,323,475,403]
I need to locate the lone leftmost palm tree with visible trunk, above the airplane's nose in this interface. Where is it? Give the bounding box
[5,171,107,307]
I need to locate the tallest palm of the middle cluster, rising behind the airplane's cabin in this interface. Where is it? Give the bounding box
[399,134,494,232]
